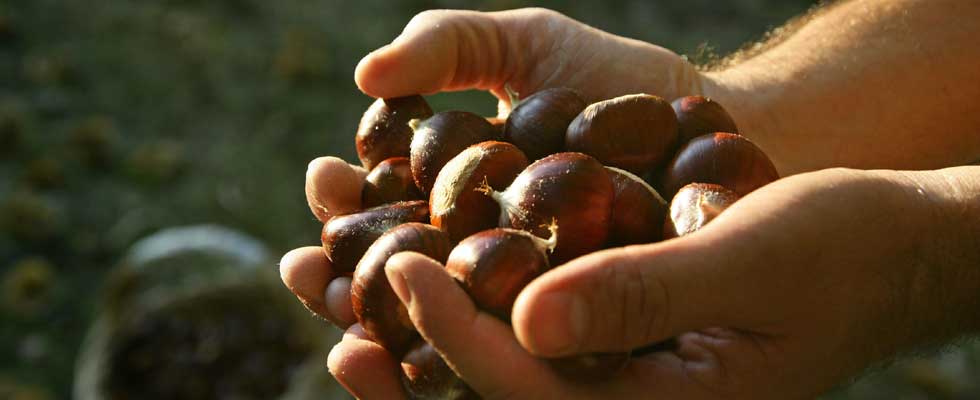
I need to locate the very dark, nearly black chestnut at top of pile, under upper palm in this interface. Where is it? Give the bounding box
[504,88,588,160]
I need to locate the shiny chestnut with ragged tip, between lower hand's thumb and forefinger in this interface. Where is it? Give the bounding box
[446,225,558,321]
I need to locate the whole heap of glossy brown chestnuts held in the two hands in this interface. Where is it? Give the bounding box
[321,88,779,399]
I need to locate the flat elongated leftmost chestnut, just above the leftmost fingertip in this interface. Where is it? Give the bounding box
[320,200,429,274]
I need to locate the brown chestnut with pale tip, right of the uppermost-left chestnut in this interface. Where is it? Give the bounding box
[409,111,500,196]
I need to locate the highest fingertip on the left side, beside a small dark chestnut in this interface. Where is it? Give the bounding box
[306,157,367,222]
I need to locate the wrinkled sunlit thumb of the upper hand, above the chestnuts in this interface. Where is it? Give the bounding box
[354,9,571,98]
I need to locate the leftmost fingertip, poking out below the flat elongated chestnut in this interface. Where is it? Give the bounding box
[279,246,334,320]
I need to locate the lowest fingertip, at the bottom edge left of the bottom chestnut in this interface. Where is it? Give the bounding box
[327,325,405,399]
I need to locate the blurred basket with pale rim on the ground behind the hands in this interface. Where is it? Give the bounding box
[73,225,348,400]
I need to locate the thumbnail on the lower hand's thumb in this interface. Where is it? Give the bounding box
[534,292,589,356]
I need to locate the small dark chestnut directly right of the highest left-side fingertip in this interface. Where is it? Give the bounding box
[361,157,422,208]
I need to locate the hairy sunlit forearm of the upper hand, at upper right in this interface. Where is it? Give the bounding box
[703,0,980,175]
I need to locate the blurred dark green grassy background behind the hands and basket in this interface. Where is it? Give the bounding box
[0,0,980,399]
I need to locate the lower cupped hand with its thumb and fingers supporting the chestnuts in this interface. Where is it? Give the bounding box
[316,166,964,399]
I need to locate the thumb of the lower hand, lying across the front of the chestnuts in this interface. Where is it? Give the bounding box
[512,232,761,357]
